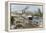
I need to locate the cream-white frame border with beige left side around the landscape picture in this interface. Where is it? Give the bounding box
[5,1,45,32]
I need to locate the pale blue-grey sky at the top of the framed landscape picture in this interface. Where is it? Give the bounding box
[11,5,42,12]
